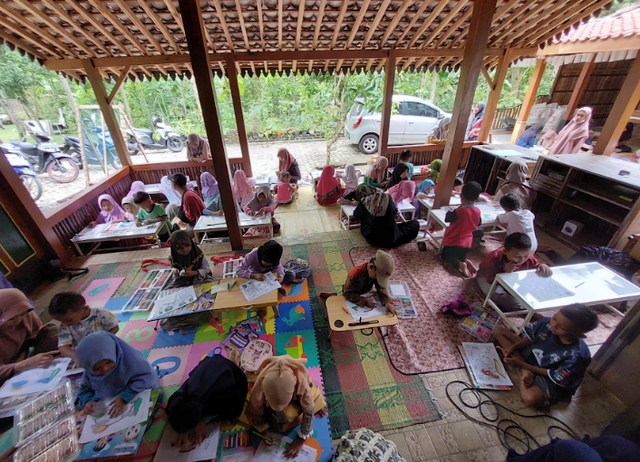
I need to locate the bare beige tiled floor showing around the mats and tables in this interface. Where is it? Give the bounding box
[31,192,624,462]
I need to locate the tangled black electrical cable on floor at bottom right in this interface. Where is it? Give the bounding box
[445,380,579,455]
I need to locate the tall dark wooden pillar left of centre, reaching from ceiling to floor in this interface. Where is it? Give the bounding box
[179,0,243,250]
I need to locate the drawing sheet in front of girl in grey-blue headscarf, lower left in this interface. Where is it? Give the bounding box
[79,390,151,443]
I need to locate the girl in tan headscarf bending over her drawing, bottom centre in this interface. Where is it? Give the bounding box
[240,355,327,457]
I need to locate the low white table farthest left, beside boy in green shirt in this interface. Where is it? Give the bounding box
[71,220,170,256]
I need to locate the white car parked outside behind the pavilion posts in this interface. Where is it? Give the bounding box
[344,95,451,154]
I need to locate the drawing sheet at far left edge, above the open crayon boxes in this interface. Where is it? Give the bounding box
[0,358,71,398]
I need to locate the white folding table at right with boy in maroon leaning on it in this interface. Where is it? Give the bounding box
[483,262,640,334]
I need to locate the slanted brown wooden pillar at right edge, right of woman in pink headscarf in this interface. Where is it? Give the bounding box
[593,54,640,156]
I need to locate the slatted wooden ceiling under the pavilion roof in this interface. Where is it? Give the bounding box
[0,0,613,78]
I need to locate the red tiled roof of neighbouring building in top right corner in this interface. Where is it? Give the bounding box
[554,6,640,43]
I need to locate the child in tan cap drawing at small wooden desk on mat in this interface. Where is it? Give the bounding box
[319,250,396,315]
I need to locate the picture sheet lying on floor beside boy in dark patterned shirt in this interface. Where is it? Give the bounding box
[460,342,513,389]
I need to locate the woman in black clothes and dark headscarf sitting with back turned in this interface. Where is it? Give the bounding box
[353,185,420,249]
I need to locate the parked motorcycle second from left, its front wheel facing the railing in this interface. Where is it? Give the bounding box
[11,129,80,183]
